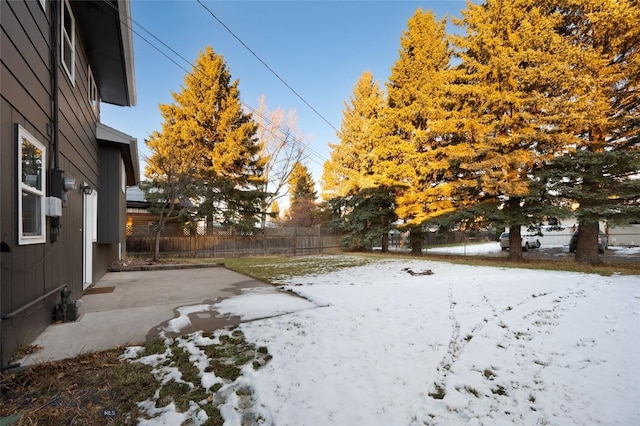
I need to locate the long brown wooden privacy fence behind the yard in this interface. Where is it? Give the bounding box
[127,228,342,257]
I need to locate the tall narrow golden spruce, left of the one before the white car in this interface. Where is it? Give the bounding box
[374,9,454,254]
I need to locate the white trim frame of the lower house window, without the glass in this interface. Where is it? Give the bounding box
[17,124,47,245]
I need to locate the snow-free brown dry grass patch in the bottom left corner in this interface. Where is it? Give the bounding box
[0,348,157,425]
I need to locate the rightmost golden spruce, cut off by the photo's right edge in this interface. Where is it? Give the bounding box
[540,0,640,264]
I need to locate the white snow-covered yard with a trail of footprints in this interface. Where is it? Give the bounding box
[127,258,640,426]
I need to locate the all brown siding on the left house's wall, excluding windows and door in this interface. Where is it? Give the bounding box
[0,0,134,361]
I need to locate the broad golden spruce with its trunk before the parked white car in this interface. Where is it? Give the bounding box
[454,0,576,260]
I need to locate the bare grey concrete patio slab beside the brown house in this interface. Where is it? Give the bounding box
[19,267,274,366]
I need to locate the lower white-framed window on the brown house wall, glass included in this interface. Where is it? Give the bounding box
[18,125,47,245]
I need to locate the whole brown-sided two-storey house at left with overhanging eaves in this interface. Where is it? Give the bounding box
[0,0,139,367]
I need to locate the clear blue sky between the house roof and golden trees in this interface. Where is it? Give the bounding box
[101,0,466,186]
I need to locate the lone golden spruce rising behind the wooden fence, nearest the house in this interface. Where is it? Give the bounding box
[152,47,265,231]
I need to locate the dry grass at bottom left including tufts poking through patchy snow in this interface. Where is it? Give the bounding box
[0,329,271,426]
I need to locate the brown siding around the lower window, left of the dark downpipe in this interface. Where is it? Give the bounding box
[0,1,58,362]
